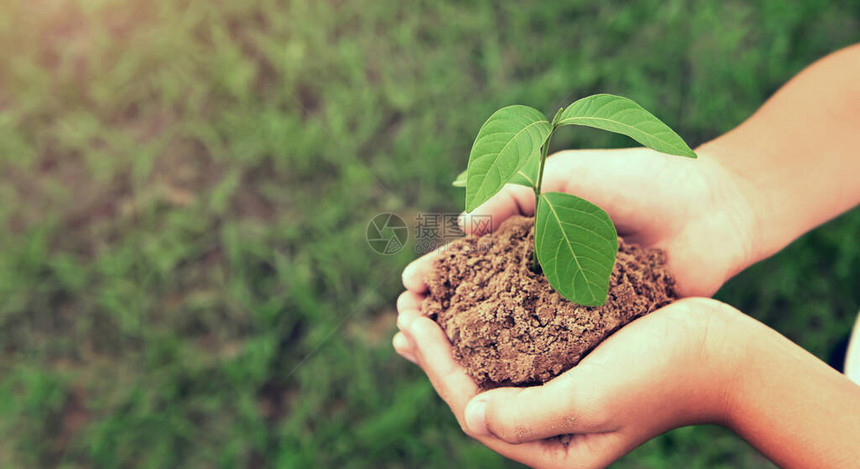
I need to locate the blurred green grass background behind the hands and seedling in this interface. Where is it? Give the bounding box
[0,0,860,468]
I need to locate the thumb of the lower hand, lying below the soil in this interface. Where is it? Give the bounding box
[464,368,607,444]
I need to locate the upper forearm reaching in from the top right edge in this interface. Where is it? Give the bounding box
[697,45,860,267]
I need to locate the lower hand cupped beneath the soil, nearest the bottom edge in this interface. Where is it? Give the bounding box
[395,292,753,467]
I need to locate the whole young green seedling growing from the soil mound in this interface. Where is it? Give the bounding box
[454,94,696,306]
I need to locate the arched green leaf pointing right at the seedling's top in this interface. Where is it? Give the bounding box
[558,94,696,158]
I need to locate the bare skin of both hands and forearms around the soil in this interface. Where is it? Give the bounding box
[394,46,860,468]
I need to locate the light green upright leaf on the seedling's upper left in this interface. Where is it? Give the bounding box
[466,105,552,212]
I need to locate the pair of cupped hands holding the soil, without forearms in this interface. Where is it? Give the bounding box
[394,148,755,467]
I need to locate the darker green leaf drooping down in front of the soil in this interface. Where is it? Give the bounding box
[535,192,618,306]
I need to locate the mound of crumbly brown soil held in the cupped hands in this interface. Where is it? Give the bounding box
[423,217,676,389]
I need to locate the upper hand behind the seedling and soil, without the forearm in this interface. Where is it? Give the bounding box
[454,148,758,296]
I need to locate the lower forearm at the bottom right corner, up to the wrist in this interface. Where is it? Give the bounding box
[728,318,860,468]
